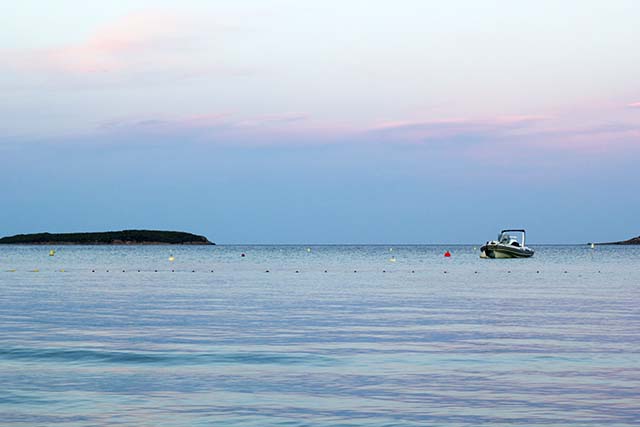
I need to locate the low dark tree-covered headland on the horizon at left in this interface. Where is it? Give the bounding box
[0,230,215,245]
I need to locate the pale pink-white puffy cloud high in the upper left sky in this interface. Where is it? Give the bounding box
[0,11,251,85]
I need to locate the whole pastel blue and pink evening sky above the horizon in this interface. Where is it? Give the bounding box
[0,0,640,244]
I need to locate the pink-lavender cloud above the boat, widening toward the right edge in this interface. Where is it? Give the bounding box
[365,108,640,165]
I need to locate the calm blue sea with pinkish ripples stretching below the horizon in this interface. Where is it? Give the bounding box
[0,246,640,427]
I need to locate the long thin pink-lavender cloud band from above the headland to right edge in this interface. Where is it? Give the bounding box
[98,112,640,159]
